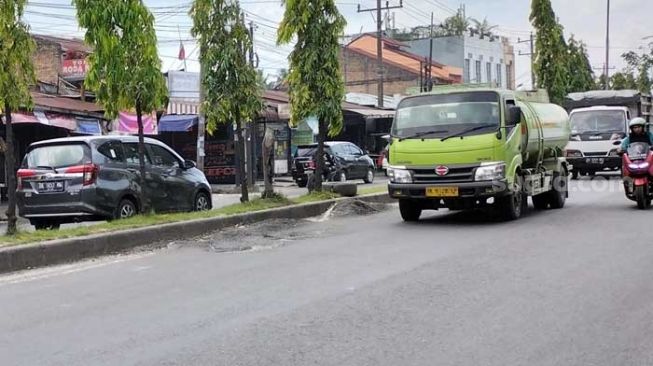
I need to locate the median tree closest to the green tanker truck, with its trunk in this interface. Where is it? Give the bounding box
[277,0,346,191]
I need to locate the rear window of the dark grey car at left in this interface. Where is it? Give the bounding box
[23,144,90,169]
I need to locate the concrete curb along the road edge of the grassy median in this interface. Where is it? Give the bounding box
[0,193,393,273]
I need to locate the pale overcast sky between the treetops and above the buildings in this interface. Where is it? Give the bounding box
[21,0,653,90]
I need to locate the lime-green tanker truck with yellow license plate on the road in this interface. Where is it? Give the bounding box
[388,86,571,221]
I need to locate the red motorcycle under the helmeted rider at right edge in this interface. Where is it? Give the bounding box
[622,142,653,209]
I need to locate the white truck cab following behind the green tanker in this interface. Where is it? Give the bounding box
[566,106,630,179]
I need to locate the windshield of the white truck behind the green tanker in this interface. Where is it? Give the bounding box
[570,110,626,135]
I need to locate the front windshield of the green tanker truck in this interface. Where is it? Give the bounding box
[392,92,499,138]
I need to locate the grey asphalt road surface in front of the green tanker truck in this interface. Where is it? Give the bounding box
[0,176,653,366]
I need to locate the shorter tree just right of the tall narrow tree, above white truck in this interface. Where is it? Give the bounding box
[567,35,596,93]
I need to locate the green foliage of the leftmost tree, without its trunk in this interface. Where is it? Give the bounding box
[0,0,36,110]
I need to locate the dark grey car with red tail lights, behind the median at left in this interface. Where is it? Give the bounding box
[17,136,212,229]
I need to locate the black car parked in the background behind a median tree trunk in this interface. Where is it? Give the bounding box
[292,141,374,187]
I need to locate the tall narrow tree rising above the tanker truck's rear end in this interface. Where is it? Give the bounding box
[530,0,568,104]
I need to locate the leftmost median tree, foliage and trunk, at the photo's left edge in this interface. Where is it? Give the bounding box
[0,0,36,235]
